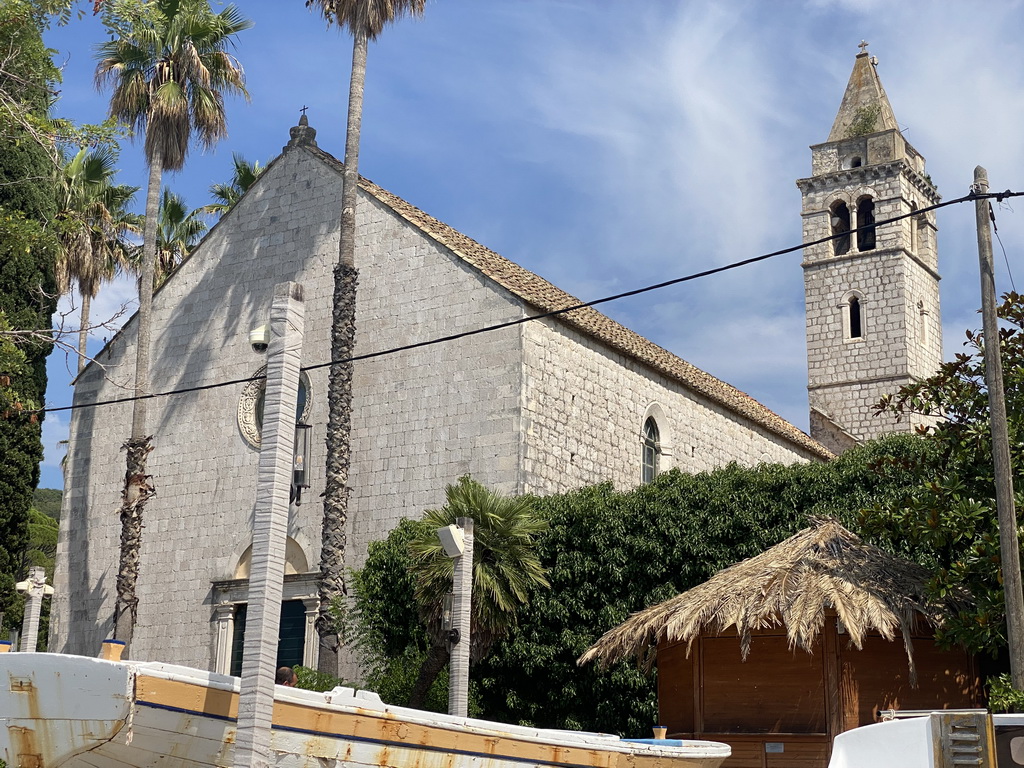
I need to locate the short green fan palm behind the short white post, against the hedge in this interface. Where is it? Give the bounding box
[409,476,550,708]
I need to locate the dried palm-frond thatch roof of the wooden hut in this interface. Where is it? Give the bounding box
[578,519,941,684]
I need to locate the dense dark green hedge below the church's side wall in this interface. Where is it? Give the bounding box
[356,436,927,736]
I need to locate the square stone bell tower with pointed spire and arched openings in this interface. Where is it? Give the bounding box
[797,43,942,453]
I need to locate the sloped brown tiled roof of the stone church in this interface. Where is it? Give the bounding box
[304,145,834,460]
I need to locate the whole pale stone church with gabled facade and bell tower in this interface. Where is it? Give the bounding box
[51,48,941,672]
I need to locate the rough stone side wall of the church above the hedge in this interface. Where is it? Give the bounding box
[522,319,810,493]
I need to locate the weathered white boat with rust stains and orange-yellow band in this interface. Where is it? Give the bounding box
[0,653,729,768]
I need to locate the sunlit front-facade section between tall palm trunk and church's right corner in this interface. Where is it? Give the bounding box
[344,192,523,567]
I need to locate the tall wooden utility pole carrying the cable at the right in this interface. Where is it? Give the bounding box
[972,166,1024,690]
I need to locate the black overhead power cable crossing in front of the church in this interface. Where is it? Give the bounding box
[35,189,1024,414]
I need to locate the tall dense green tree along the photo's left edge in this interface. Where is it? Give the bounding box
[0,0,59,643]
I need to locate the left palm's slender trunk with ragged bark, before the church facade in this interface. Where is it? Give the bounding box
[114,153,163,654]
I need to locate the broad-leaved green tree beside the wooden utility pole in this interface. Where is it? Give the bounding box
[864,293,1024,654]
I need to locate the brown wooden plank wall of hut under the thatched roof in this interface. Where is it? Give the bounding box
[657,621,981,768]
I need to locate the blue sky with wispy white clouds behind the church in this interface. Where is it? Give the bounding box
[41,0,1024,487]
